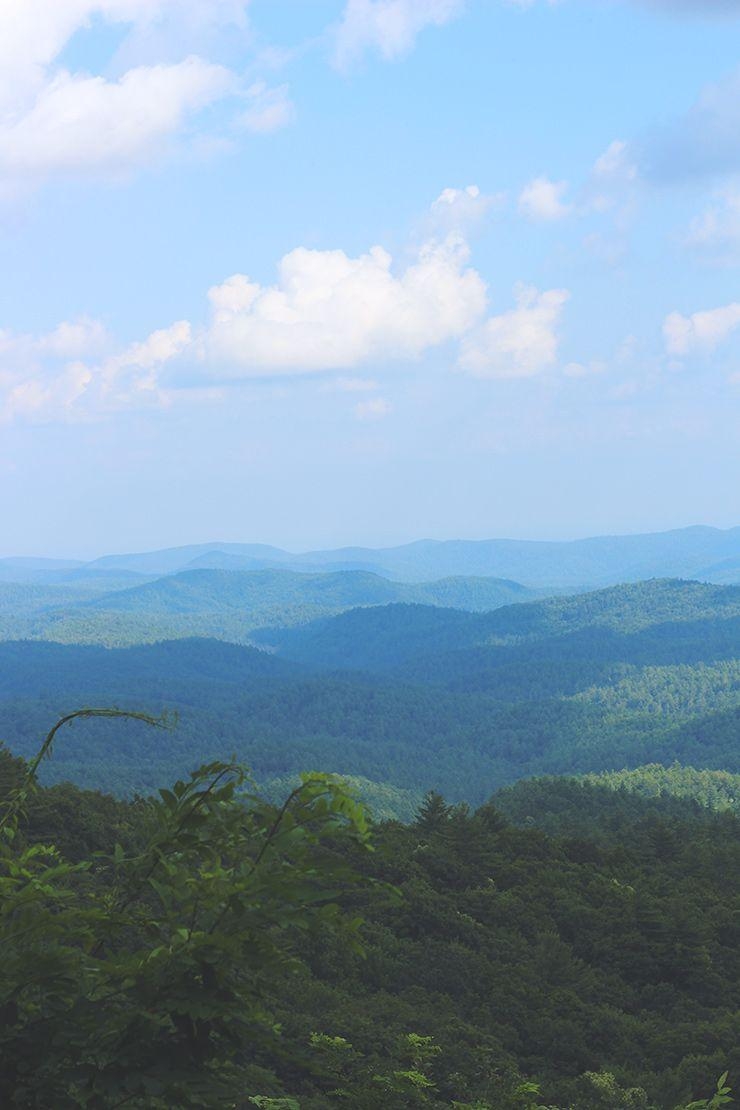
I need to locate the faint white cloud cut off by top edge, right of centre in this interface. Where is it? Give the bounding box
[334,0,464,70]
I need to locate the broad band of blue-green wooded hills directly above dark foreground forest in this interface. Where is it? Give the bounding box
[0,579,740,816]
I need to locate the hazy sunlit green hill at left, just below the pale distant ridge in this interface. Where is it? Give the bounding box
[0,569,537,647]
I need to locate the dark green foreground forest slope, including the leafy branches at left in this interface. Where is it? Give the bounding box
[5,737,740,1110]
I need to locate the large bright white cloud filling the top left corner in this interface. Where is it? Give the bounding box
[0,0,246,187]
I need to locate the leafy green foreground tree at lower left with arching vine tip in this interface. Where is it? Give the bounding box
[0,710,368,1110]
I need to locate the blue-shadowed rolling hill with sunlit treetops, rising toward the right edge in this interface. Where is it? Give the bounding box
[265,579,740,685]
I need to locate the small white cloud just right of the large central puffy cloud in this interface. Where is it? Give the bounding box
[459,285,570,377]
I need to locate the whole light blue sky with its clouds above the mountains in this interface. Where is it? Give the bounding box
[0,0,740,558]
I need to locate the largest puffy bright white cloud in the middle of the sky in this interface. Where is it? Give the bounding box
[200,235,486,377]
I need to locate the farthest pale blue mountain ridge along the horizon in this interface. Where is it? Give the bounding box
[0,525,740,589]
